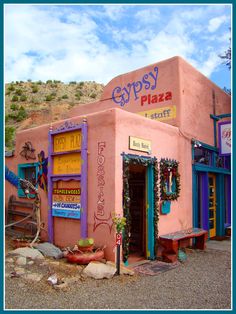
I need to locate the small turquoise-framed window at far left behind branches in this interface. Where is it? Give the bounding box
[18,163,38,198]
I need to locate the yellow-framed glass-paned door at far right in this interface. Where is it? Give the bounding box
[208,173,217,238]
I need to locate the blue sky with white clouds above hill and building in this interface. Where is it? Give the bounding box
[4,4,231,88]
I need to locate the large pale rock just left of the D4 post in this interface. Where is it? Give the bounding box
[82,262,116,279]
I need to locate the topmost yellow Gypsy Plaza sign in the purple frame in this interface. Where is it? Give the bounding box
[53,130,82,153]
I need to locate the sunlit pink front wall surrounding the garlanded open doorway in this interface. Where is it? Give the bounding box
[112,109,192,235]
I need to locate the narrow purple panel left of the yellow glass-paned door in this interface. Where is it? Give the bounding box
[200,172,209,230]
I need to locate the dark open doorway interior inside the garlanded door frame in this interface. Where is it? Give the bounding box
[129,165,146,259]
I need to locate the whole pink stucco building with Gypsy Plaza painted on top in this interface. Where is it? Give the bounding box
[5,57,231,261]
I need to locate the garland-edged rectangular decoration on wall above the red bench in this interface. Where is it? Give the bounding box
[160,158,180,201]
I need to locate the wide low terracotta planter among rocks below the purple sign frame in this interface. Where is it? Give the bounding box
[66,250,104,265]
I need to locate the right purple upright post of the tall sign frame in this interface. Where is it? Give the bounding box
[81,122,88,238]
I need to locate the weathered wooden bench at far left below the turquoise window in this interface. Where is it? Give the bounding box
[6,195,37,237]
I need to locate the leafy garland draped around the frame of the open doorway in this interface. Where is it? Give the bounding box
[122,154,159,262]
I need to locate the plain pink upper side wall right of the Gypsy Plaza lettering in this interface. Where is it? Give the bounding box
[179,58,231,146]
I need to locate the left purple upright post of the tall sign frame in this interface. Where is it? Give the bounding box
[48,130,54,243]
